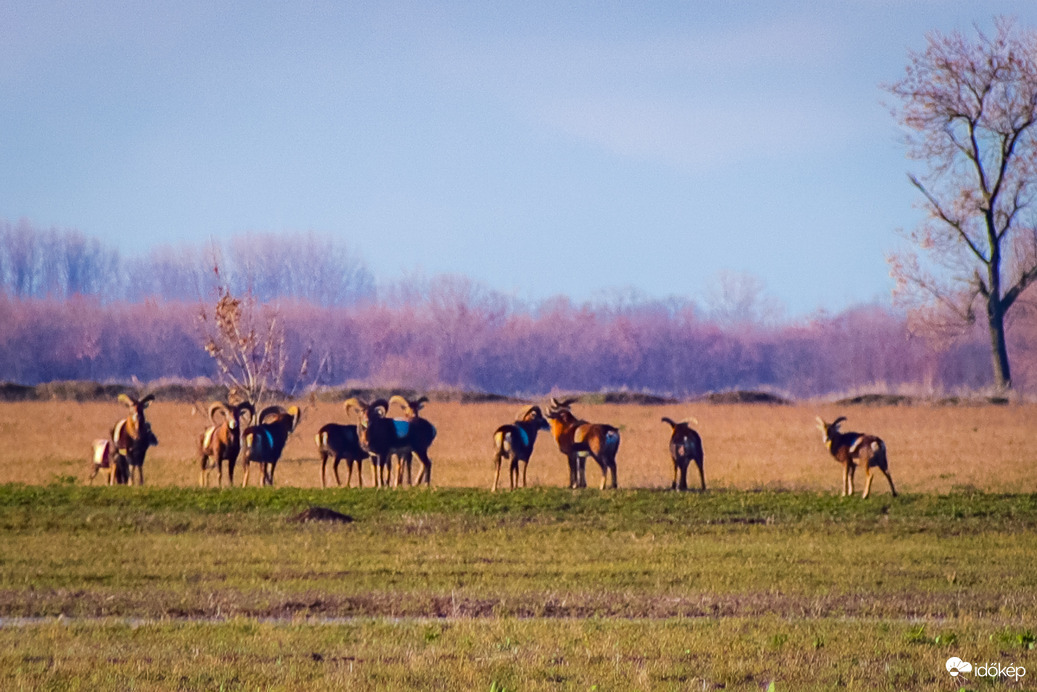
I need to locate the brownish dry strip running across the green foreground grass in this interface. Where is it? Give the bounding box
[0,588,1003,620]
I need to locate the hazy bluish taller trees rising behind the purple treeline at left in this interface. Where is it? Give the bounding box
[0,220,374,306]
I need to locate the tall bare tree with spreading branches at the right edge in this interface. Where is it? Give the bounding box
[885,19,1037,389]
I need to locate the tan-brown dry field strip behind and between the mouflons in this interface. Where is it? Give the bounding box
[0,402,1037,494]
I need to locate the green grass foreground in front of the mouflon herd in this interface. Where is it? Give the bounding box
[0,483,1037,690]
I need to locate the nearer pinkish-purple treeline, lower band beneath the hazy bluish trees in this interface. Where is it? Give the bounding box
[0,293,1020,398]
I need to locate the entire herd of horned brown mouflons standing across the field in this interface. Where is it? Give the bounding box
[89,394,897,498]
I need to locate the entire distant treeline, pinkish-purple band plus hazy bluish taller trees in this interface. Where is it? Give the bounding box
[0,222,1037,398]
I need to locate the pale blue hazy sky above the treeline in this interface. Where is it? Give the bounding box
[0,0,1037,314]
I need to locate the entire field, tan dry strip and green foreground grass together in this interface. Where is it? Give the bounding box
[0,402,1037,692]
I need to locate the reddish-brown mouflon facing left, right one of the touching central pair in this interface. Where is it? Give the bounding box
[548,398,619,490]
